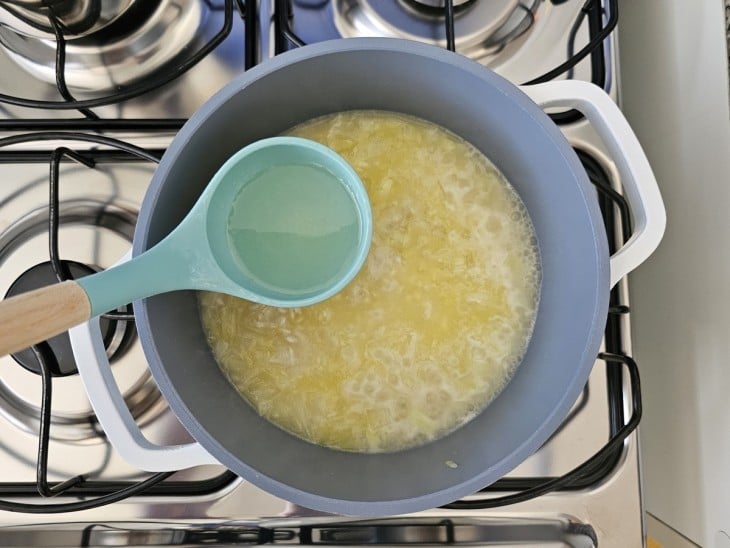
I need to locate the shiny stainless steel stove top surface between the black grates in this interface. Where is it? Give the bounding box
[0,0,643,547]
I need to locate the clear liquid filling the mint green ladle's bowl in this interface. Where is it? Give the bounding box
[227,165,360,295]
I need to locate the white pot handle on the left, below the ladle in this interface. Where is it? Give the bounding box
[69,252,220,472]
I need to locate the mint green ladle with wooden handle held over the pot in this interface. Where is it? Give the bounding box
[0,137,372,355]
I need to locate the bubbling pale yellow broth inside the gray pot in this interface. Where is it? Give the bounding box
[200,111,540,452]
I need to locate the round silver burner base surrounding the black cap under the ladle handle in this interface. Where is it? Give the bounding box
[0,198,166,444]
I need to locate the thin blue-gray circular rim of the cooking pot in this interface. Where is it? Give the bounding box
[133,38,609,515]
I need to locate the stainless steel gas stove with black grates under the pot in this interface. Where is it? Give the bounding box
[0,0,643,547]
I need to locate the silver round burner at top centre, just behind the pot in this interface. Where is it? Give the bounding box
[332,0,540,59]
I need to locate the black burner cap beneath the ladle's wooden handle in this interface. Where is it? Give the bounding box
[5,261,136,377]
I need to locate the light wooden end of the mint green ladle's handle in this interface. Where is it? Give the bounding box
[0,281,91,356]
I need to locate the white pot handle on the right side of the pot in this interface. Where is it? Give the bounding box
[520,80,666,287]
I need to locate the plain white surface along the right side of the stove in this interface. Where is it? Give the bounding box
[619,0,730,548]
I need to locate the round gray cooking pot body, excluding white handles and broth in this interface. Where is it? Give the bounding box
[133,39,663,515]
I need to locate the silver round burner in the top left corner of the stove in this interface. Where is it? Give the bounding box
[0,0,207,91]
